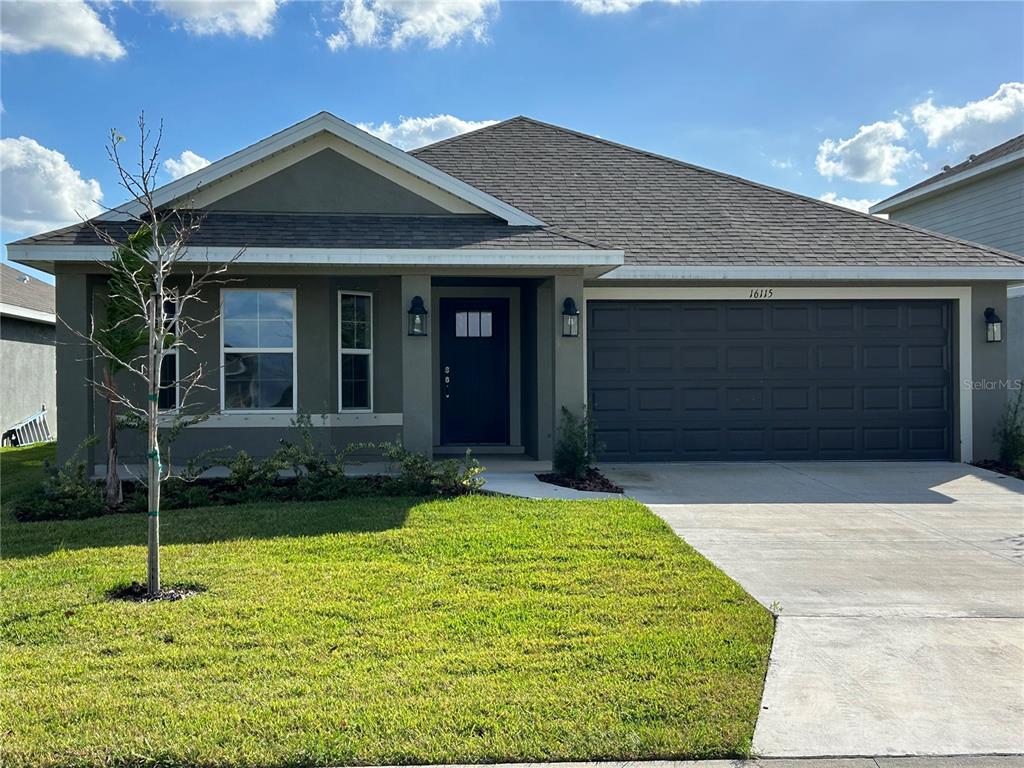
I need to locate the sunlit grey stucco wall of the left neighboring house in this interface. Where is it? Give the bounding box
[0,317,57,433]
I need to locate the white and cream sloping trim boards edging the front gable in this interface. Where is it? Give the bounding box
[97,112,544,226]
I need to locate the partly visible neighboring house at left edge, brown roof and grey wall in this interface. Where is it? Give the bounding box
[0,262,57,434]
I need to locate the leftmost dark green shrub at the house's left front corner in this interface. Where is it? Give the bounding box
[14,437,106,521]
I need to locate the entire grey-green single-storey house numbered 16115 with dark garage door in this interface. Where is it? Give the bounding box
[9,113,1024,468]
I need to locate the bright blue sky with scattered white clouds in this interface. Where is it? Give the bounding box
[0,0,1024,278]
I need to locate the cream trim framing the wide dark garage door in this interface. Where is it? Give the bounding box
[583,281,974,464]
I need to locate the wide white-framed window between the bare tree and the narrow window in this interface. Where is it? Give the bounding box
[221,289,295,411]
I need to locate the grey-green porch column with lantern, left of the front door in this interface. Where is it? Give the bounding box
[401,274,436,457]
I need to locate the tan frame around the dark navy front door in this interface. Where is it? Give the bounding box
[430,286,522,449]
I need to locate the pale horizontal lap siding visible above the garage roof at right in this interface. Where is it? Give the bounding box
[890,165,1024,254]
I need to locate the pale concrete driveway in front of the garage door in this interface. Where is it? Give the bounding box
[602,463,1024,757]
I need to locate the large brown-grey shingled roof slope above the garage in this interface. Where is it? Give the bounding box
[412,117,1024,267]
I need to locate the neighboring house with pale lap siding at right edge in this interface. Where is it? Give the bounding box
[871,134,1024,393]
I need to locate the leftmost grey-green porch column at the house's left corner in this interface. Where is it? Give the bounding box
[55,273,94,466]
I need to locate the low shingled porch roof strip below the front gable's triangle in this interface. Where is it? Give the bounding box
[13,212,601,250]
